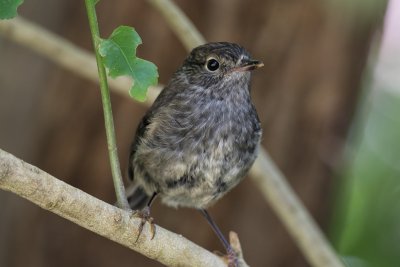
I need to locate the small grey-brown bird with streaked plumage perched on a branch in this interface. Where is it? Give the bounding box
[128,42,264,266]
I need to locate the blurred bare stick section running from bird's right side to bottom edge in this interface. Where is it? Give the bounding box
[250,151,343,267]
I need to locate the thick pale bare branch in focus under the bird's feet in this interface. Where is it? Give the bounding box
[0,149,226,267]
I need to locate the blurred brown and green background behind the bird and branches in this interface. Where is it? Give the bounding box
[0,0,400,267]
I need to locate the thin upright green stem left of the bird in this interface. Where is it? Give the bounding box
[85,0,129,209]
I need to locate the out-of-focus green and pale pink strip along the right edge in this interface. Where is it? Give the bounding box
[332,1,400,267]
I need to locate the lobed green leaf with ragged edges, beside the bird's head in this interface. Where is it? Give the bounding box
[99,26,158,101]
